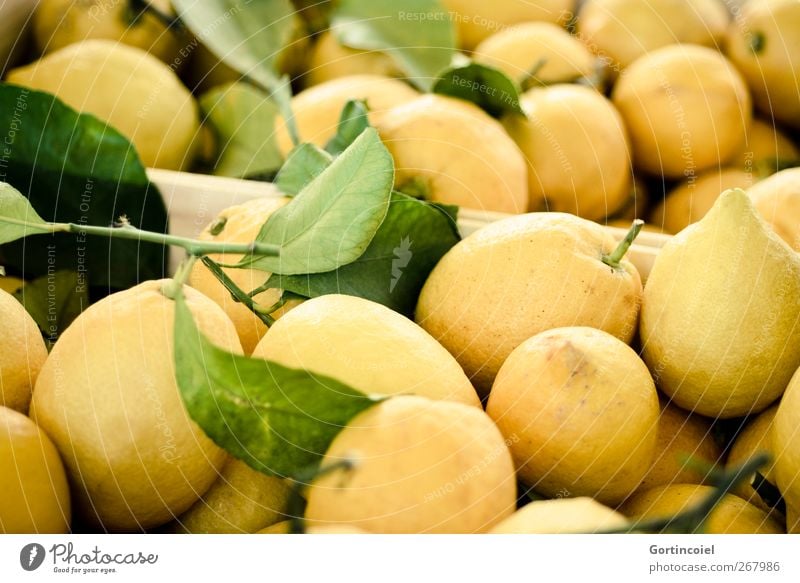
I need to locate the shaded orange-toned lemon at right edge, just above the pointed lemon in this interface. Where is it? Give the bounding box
[731,118,800,178]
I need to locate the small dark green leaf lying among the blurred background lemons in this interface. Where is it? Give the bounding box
[433,63,525,117]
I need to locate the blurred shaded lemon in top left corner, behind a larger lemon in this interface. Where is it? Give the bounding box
[33,0,184,64]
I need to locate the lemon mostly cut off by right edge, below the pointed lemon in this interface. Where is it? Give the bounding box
[768,369,800,531]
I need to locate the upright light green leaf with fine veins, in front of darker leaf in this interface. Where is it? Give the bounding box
[238,128,394,275]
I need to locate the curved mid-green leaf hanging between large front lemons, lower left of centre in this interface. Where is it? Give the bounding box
[174,295,382,477]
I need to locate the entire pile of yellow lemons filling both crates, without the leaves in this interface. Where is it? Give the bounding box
[0,0,800,533]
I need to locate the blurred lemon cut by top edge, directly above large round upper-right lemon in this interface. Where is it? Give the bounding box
[576,0,730,73]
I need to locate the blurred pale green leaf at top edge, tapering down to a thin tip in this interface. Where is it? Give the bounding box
[172,0,298,143]
